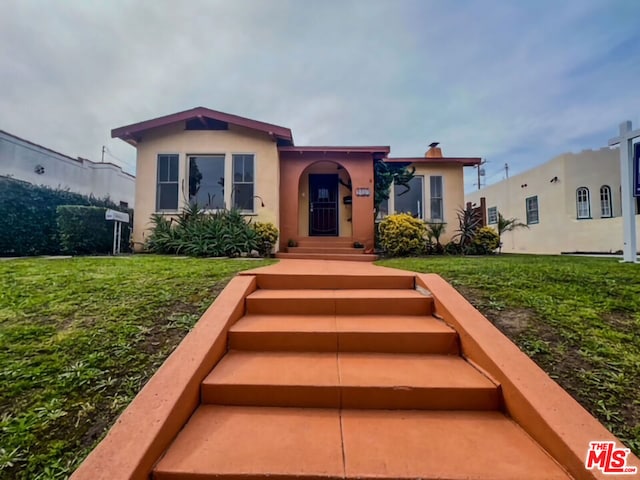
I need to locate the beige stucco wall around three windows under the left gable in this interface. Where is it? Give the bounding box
[133,123,280,250]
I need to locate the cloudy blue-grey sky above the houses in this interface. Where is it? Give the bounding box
[0,0,640,190]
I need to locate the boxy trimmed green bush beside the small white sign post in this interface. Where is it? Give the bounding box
[57,205,113,255]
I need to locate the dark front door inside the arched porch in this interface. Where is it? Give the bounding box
[309,174,338,237]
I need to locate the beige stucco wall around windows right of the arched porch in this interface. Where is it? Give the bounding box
[389,163,464,243]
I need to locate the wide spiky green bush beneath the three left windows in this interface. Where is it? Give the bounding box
[145,205,259,257]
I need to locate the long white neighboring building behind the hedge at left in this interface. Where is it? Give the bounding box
[0,130,135,208]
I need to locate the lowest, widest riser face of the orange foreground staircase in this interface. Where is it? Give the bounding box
[202,384,499,410]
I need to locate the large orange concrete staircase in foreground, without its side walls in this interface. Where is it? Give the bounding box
[152,272,570,480]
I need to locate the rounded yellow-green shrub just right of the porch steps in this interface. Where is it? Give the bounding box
[378,213,426,256]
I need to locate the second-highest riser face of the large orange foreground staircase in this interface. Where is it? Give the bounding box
[247,297,433,315]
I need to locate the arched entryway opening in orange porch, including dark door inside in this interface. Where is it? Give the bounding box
[298,160,353,237]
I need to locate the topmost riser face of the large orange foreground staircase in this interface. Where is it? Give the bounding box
[258,275,415,290]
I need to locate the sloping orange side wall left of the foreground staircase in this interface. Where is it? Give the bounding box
[71,275,256,480]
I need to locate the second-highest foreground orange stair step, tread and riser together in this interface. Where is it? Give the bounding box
[246,289,433,315]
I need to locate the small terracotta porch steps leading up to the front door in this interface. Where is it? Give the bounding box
[276,237,378,262]
